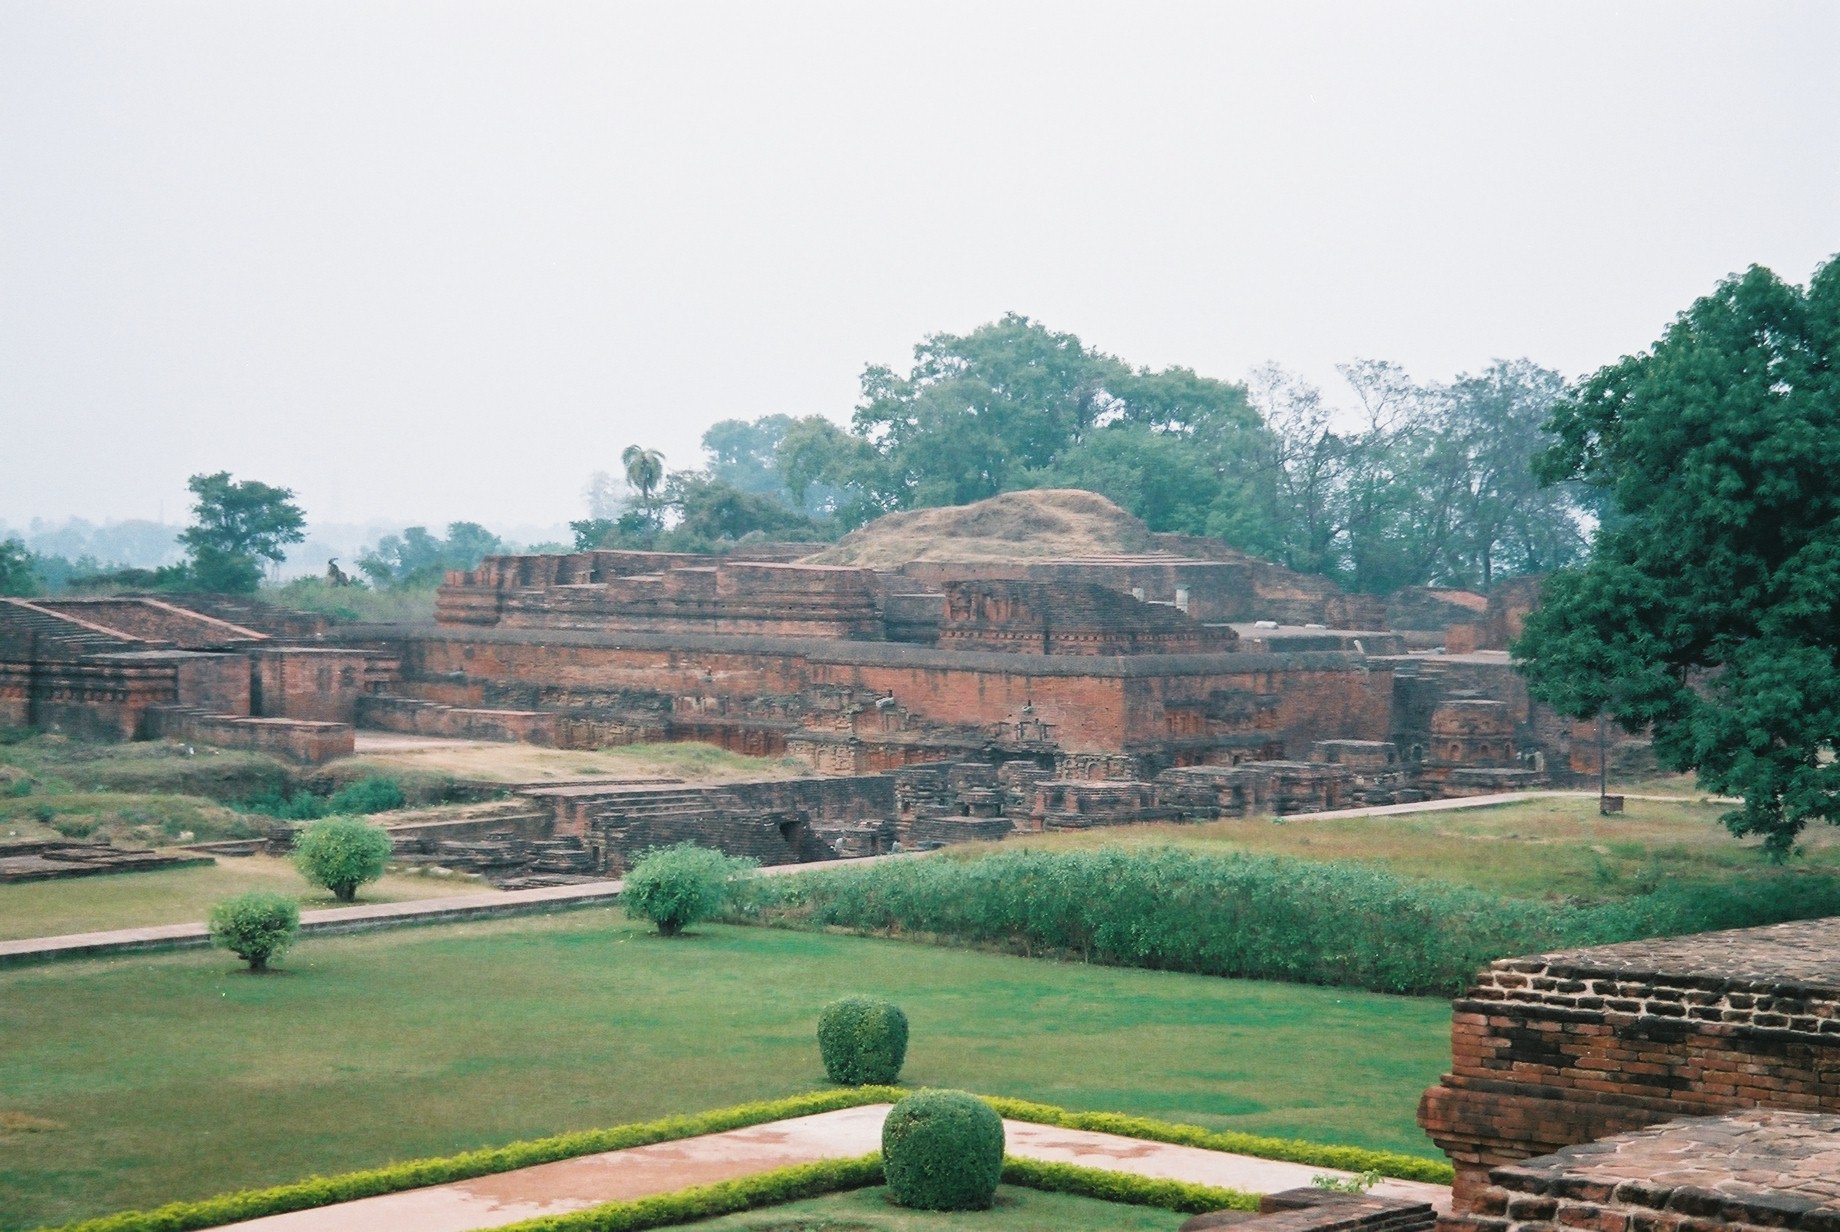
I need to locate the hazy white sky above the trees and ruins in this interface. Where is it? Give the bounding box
[0,0,1840,524]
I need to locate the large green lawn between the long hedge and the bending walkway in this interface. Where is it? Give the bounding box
[0,908,1450,1228]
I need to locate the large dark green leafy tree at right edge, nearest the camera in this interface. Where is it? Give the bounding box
[1514,259,1840,855]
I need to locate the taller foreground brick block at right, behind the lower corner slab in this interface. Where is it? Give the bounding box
[1419,919,1840,1208]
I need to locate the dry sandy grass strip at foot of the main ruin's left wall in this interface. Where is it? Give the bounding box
[340,732,811,783]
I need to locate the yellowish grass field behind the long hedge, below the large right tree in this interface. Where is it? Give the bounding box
[986,796,1840,901]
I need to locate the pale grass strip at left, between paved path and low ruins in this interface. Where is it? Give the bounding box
[0,855,491,941]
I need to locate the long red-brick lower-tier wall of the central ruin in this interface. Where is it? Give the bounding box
[373,631,1391,769]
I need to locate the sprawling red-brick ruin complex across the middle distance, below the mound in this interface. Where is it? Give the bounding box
[0,537,1626,872]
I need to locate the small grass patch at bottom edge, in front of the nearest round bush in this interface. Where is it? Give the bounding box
[683,1184,1189,1232]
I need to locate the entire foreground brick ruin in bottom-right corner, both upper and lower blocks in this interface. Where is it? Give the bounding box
[1419,919,1840,1232]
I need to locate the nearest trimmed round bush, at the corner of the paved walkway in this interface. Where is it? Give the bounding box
[881,1090,1003,1210]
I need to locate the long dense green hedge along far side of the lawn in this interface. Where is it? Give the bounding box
[739,848,1836,997]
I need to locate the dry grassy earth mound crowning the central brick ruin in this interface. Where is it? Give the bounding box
[804,487,1238,568]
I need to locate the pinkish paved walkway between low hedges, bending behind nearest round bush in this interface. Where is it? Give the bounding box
[215,1103,1450,1232]
